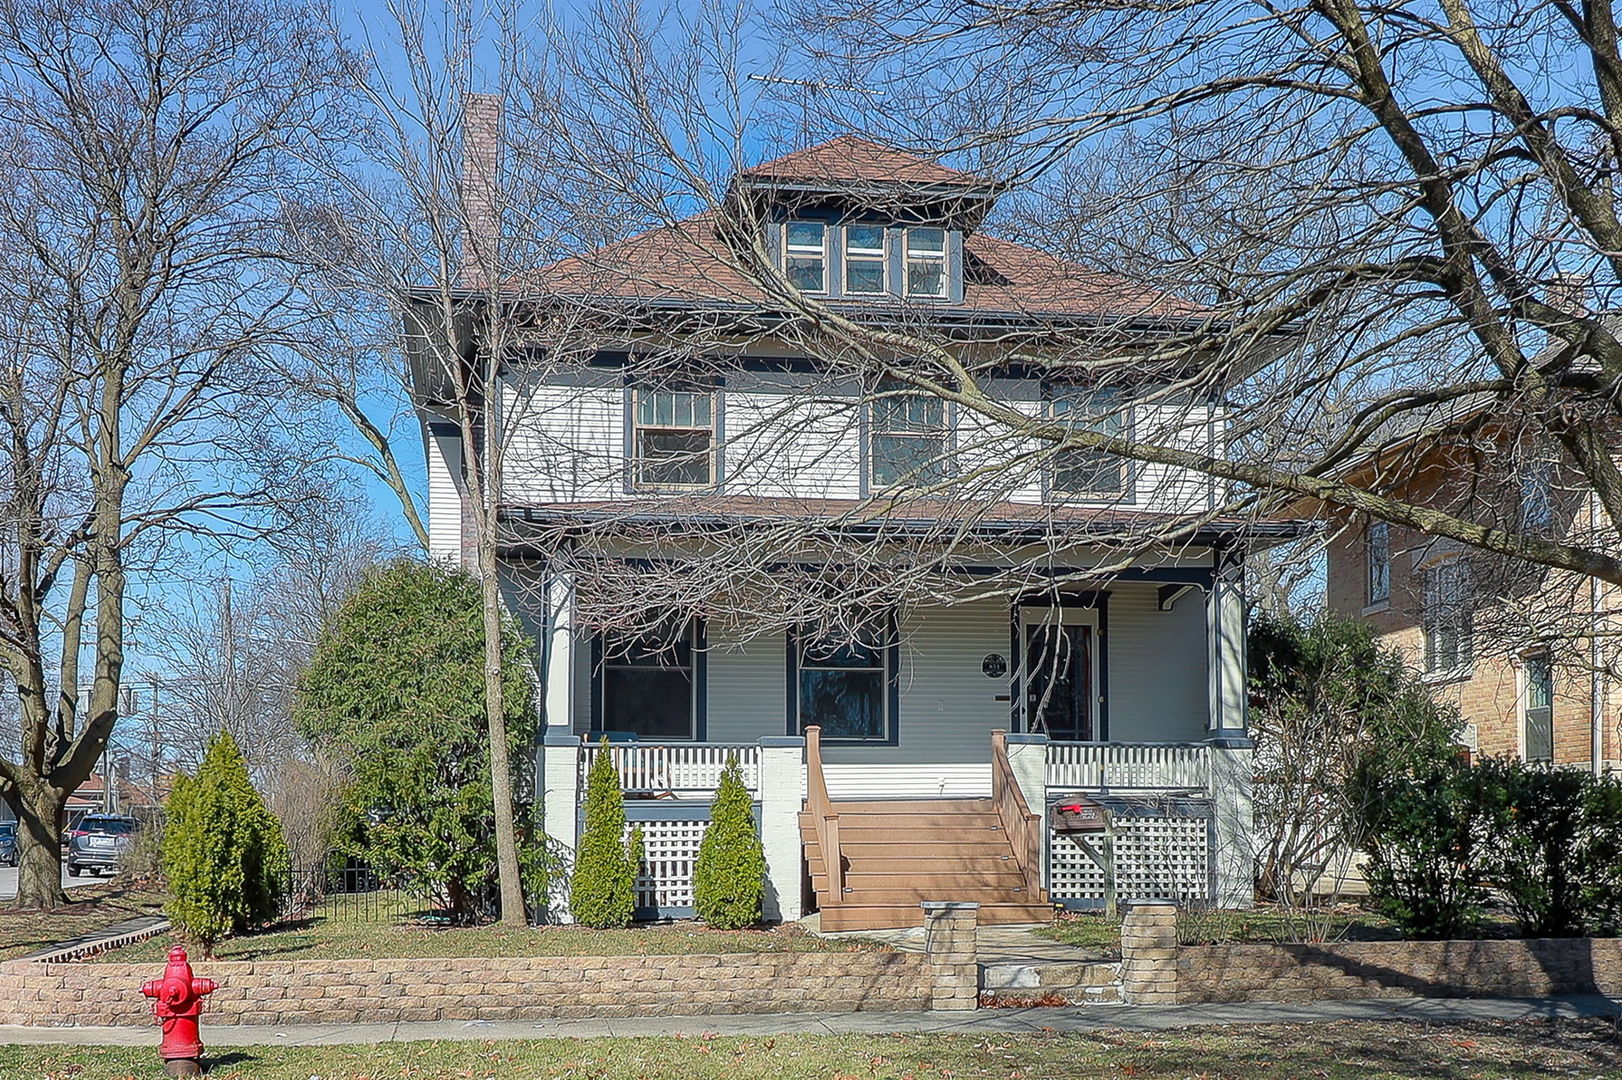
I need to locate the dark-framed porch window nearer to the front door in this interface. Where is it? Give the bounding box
[796,622,892,741]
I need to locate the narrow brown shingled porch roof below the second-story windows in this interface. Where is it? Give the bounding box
[501,493,1320,545]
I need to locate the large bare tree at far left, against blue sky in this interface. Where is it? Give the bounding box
[0,0,334,906]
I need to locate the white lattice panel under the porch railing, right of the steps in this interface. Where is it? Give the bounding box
[1048,807,1212,900]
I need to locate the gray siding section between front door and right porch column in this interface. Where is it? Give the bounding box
[1108,584,1210,743]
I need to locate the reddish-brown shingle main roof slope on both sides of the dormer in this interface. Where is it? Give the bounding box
[539,214,1207,319]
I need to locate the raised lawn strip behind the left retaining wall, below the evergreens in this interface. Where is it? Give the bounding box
[99,900,884,963]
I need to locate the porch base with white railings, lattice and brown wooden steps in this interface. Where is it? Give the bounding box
[542,730,1252,929]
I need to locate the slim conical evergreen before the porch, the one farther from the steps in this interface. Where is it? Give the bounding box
[569,739,642,929]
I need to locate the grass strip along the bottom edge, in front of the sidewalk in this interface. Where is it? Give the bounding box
[0,1020,1622,1080]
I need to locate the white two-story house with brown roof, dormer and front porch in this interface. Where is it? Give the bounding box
[414,113,1302,929]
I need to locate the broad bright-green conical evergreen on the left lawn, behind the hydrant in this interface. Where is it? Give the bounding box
[162,731,289,957]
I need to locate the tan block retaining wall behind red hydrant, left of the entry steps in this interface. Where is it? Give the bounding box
[0,953,947,1025]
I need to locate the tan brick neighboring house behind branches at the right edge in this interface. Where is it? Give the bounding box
[1327,408,1622,774]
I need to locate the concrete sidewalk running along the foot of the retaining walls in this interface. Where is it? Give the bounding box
[0,996,1622,1046]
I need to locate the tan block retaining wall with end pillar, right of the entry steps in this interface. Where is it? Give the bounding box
[1121,905,1622,1004]
